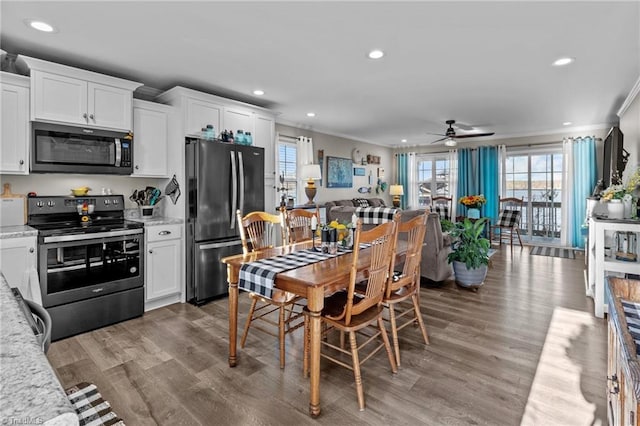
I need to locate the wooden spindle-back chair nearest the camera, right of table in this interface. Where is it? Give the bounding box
[303,214,400,411]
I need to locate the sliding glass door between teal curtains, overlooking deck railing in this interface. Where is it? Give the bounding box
[503,147,562,244]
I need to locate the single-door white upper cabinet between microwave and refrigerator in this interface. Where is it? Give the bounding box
[133,99,171,177]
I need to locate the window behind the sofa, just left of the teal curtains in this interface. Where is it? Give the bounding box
[417,154,451,207]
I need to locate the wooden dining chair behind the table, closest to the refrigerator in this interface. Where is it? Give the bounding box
[236,210,304,368]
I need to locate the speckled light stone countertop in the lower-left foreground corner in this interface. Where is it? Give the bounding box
[0,273,78,426]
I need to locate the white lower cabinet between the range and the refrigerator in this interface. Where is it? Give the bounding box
[144,224,183,310]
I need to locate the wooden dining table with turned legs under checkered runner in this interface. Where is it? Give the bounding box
[222,242,392,417]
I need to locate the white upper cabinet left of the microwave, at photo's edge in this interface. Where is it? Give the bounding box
[0,72,29,175]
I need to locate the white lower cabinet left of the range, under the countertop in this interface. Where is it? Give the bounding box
[0,236,37,289]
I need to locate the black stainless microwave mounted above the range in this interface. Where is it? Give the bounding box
[31,122,133,175]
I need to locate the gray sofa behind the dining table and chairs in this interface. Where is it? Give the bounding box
[324,198,453,286]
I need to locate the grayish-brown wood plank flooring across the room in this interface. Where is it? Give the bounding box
[48,246,606,426]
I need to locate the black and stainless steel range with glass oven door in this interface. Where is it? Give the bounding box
[27,195,144,340]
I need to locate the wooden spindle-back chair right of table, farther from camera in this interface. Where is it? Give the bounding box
[382,213,429,367]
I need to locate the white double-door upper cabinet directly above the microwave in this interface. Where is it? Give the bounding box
[21,56,141,131]
